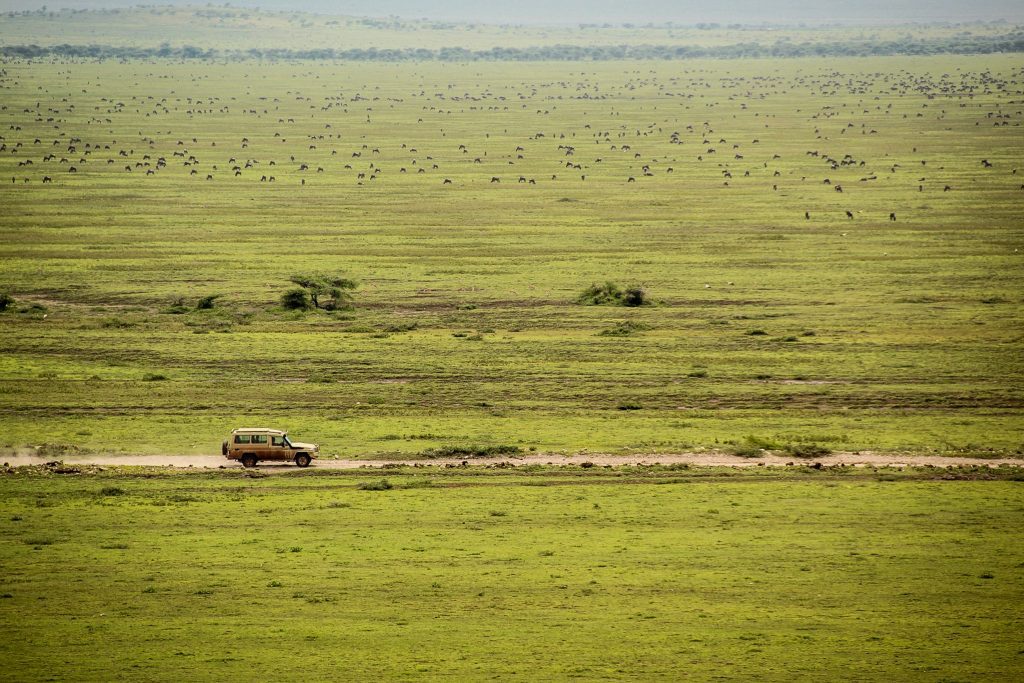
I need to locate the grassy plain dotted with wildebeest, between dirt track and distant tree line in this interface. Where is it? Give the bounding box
[0,54,1024,457]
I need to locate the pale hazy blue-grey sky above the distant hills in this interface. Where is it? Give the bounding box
[0,0,1024,24]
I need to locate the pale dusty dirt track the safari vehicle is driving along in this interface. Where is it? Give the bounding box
[0,453,1024,471]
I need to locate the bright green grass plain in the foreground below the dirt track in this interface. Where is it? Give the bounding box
[0,467,1024,681]
